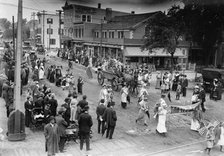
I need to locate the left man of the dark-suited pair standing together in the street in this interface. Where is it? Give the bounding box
[96,99,106,134]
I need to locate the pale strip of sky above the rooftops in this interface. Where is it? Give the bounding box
[0,0,182,21]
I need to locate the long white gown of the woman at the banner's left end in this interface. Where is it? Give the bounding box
[156,107,167,133]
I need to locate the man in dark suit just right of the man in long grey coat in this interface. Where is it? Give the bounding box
[55,109,68,152]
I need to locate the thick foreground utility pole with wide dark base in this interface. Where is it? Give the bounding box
[8,0,26,141]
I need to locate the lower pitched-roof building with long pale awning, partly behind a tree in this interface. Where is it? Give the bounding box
[93,12,189,68]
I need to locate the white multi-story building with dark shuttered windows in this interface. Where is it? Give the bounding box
[37,12,64,49]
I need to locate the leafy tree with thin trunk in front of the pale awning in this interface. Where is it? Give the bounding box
[142,6,185,70]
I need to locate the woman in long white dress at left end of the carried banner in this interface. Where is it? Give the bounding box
[156,102,167,137]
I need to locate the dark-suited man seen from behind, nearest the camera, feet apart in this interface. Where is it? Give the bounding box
[78,105,93,151]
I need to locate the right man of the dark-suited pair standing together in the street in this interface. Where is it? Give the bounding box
[103,103,117,139]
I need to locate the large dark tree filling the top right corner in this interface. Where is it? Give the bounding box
[182,0,224,65]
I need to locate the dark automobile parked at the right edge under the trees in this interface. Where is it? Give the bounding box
[202,68,224,92]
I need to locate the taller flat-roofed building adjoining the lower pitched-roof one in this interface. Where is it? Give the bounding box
[62,1,130,56]
